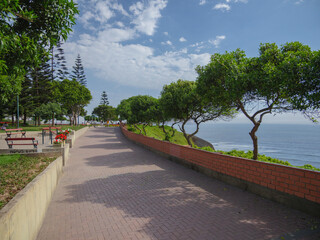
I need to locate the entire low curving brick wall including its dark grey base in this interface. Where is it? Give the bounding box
[121,124,320,216]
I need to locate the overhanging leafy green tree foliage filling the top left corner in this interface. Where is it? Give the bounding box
[0,0,78,102]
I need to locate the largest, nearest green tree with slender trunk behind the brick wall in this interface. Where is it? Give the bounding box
[196,43,316,159]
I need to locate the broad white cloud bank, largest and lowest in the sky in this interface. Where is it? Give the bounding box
[65,34,210,90]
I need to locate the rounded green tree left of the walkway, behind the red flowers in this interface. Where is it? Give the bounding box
[54,79,92,125]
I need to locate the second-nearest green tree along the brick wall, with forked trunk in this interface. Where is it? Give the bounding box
[160,80,235,146]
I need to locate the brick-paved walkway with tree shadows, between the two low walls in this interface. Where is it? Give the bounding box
[38,128,320,240]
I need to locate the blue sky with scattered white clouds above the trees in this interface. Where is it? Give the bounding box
[64,0,320,122]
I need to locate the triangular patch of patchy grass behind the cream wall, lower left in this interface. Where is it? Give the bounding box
[0,154,56,209]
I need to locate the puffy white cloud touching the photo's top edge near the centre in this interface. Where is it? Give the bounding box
[130,0,168,36]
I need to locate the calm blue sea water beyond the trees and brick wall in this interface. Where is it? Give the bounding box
[182,123,320,168]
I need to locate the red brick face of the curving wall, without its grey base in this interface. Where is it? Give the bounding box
[122,124,320,203]
